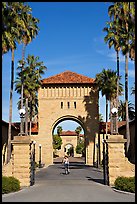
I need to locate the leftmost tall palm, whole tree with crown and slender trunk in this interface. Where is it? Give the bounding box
[2,2,26,163]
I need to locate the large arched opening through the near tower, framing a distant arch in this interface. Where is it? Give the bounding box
[52,115,85,161]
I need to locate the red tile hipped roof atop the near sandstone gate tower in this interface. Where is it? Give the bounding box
[41,71,95,84]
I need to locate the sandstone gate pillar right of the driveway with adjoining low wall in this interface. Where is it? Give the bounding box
[106,135,135,186]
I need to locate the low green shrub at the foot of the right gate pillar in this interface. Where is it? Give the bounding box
[114,176,135,193]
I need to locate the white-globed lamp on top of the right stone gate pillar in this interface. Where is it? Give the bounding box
[111,107,118,134]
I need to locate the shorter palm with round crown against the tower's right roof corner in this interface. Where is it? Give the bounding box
[95,69,122,135]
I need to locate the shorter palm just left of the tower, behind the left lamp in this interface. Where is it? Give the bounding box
[15,55,47,134]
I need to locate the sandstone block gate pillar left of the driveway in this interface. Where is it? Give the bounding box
[11,136,31,187]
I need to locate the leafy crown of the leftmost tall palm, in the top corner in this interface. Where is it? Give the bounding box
[2,2,23,54]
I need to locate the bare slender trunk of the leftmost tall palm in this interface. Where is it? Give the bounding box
[7,49,14,163]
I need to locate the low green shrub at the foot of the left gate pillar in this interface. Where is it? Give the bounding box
[2,176,20,194]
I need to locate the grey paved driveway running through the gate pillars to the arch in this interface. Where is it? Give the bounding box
[2,158,135,202]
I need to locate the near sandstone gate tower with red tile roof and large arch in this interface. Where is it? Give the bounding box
[33,71,99,165]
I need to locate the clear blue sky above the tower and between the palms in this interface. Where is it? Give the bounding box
[2,2,135,129]
